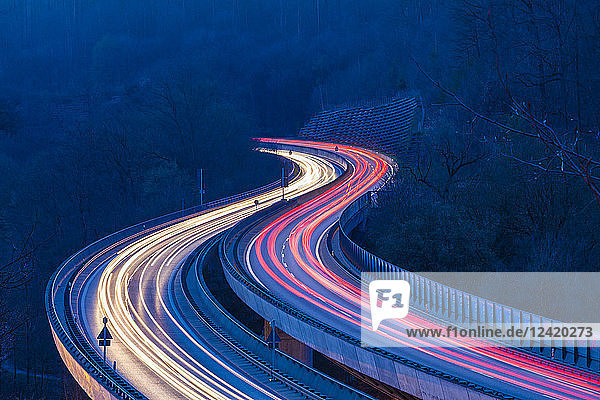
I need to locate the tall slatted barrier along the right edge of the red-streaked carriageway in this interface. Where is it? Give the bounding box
[339,191,600,379]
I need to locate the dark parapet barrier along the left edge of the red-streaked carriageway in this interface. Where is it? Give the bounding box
[219,144,516,400]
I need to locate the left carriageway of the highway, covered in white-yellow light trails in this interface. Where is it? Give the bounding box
[70,148,340,400]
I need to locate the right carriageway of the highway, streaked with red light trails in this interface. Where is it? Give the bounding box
[244,140,600,399]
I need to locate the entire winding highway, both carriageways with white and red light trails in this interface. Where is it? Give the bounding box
[50,139,600,400]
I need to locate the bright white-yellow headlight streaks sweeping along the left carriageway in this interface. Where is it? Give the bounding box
[70,148,337,400]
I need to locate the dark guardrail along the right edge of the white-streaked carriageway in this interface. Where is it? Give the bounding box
[181,234,375,400]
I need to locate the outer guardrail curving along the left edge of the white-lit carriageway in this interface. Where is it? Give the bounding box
[45,162,299,400]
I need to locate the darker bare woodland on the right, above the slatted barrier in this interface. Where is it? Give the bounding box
[356,1,600,271]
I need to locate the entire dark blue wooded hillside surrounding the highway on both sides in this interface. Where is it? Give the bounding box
[0,0,600,399]
